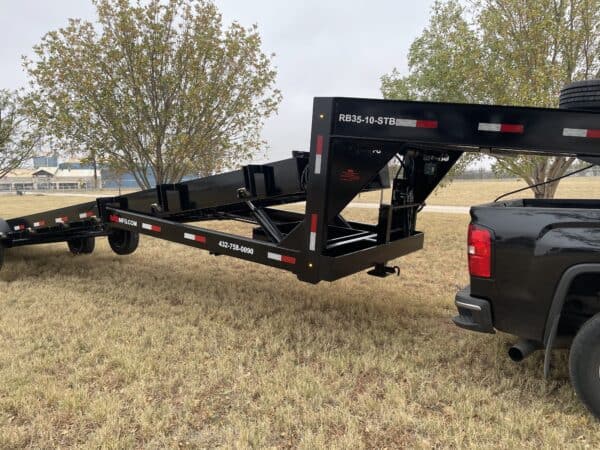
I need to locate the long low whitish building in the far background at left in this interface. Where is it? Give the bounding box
[0,163,102,192]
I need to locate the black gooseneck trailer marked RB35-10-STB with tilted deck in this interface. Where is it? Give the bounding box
[0,98,600,283]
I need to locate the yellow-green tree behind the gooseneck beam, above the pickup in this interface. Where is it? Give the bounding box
[382,0,600,198]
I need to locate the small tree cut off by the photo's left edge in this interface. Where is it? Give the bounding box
[0,90,39,178]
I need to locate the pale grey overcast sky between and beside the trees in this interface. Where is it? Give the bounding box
[0,0,433,159]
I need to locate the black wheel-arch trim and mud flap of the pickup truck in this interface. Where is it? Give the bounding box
[543,264,600,378]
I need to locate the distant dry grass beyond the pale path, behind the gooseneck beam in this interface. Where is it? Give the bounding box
[357,177,600,206]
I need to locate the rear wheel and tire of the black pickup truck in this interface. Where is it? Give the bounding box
[569,314,600,419]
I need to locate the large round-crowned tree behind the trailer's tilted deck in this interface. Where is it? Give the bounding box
[25,0,281,188]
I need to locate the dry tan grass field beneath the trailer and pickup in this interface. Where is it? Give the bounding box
[0,180,600,449]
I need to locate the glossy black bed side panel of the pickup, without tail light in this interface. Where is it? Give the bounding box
[469,199,600,342]
